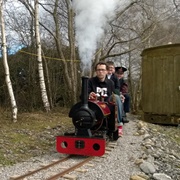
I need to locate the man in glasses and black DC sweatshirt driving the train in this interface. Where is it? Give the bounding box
[88,62,123,136]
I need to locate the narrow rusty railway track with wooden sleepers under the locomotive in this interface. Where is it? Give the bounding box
[10,143,116,180]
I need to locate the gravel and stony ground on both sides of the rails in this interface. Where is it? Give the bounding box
[0,114,180,180]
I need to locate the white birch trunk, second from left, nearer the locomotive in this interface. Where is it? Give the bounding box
[34,0,50,112]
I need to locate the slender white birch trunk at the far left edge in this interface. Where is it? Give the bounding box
[0,0,18,122]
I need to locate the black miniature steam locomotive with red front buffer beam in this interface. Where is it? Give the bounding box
[56,77,118,156]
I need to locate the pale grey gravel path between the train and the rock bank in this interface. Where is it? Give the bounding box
[76,116,143,180]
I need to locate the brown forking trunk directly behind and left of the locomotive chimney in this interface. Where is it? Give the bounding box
[53,0,77,104]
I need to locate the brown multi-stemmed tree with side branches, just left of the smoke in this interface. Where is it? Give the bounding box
[41,0,79,104]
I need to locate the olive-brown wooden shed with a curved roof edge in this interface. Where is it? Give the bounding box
[142,44,180,124]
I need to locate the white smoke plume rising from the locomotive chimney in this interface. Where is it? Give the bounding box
[73,0,117,73]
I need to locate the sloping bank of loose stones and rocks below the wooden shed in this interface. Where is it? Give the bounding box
[137,123,180,180]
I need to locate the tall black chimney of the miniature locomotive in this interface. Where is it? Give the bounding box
[81,76,89,107]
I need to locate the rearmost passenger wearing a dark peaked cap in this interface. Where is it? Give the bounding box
[115,66,130,123]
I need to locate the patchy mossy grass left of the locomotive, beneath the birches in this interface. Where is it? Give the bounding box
[0,109,72,166]
